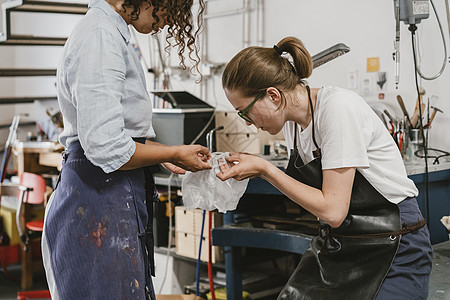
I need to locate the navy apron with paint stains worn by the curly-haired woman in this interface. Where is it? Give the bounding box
[43,141,157,300]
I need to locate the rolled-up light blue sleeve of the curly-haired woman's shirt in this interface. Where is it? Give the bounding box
[67,27,136,173]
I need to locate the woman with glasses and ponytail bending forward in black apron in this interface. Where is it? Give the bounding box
[217,37,432,299]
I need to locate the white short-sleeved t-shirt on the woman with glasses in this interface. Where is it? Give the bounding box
[283,87,418,204]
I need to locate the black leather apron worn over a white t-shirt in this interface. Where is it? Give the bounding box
[278,87,401,300]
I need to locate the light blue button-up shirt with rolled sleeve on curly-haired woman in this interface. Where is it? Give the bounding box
[57,0,155,173]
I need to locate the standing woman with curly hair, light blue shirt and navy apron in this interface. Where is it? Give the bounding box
[42,0,210,300]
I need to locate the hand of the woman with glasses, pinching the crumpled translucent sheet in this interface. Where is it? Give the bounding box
[217,153,268,181]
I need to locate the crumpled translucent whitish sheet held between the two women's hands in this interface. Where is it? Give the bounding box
[181,152,248,212]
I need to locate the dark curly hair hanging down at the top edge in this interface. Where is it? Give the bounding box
[122,0,205,81]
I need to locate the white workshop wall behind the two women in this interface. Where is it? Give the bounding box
[0,0,450,151]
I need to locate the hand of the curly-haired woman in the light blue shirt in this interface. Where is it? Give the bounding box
[172,145,211,172]
